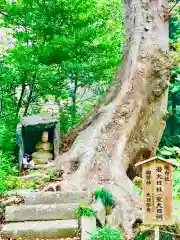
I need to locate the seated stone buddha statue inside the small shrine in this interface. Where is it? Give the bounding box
[32,132,53,164]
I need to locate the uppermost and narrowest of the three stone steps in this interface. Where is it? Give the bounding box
[25,191,89,205]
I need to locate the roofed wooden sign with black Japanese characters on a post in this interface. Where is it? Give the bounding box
[135,157,178,239]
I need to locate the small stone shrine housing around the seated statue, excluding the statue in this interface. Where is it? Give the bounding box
[16,113,60,171]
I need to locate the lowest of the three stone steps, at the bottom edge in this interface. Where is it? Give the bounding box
[2,220,78,240]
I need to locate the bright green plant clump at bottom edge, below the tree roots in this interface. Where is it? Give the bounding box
[89,228,122,240]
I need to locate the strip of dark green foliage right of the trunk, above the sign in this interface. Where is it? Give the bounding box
[160,2,180,147]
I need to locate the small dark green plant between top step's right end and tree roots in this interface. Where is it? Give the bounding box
[95,188,115,207]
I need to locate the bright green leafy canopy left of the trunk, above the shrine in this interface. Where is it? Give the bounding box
[1,0,123,116]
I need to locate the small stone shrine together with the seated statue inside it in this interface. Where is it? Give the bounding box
[16,113,60,171]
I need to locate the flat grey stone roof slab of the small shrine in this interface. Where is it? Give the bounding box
[20,113,59,127]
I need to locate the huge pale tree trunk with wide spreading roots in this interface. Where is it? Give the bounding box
[56,0,170,236]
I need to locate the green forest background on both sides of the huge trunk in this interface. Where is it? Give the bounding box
[0,0,180,198]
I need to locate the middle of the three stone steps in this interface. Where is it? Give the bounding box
[5,204,78,222]
